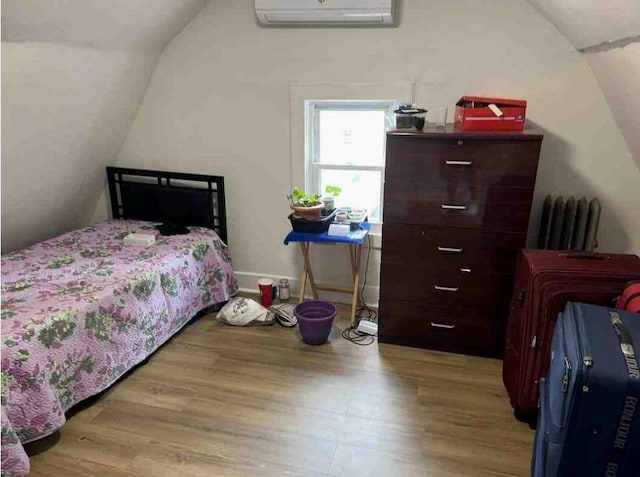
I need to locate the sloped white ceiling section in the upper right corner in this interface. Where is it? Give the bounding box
[529,0,640,169]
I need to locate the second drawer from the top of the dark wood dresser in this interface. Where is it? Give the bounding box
[384,181,533,233]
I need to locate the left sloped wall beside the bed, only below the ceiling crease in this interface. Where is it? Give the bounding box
[2,42,158,253]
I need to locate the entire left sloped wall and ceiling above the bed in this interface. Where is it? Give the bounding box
[2,0,205,253]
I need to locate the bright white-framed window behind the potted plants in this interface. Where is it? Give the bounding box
[305,100,396,223]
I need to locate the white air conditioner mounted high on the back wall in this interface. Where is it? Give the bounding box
[255,0,394,26]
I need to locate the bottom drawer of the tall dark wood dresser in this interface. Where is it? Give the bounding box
[378,300,504,357]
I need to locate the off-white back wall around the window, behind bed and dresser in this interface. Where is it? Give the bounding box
[107,0,640,302]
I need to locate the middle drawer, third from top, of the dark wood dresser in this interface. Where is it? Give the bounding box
[382,223,527,273]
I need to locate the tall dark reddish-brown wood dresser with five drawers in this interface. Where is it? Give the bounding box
[379,129,542,357]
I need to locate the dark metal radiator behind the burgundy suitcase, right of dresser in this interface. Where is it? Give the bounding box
[538,195,601,252]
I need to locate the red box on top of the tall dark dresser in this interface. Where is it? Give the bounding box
[455,96,527,131]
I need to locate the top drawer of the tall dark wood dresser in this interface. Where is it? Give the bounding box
[385,136,541,189]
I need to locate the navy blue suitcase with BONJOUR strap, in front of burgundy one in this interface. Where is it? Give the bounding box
[531,303,640,477]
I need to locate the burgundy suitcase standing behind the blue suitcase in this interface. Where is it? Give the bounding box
[502,250,640,422]
